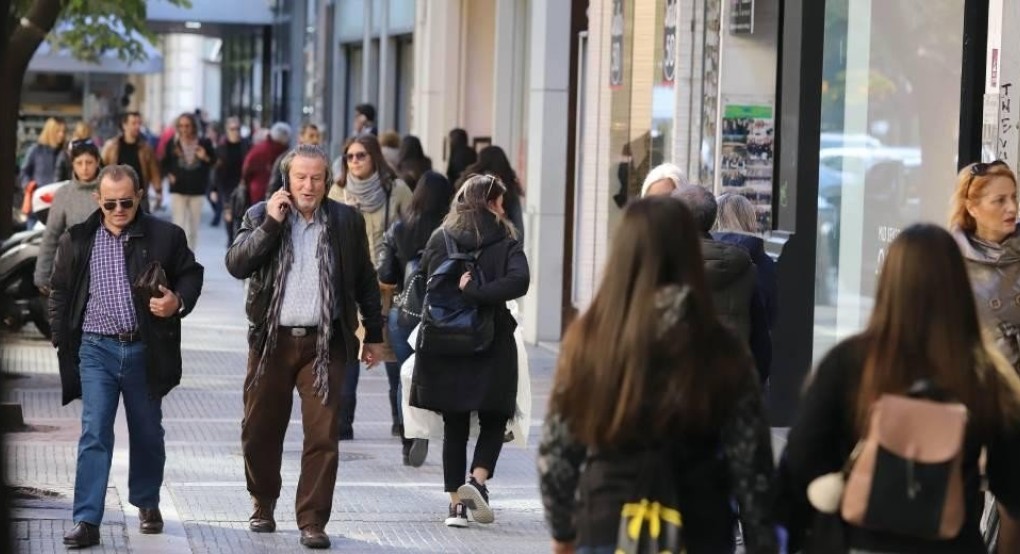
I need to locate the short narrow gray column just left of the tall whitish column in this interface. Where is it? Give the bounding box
[493,0,527,162]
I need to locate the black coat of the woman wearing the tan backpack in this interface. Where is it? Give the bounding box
[779,337,1020,554]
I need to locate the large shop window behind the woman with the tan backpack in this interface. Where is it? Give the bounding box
[814,0,965,358]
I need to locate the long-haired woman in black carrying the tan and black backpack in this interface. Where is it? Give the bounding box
[785,224,1020,554]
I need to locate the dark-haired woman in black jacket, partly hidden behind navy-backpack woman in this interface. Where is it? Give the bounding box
[378,171,453,467]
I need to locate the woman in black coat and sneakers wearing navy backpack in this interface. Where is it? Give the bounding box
[410,175,530,527]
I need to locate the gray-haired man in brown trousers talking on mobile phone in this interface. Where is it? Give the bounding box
[226,145,383,549]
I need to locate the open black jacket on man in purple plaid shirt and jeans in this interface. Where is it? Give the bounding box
[49,210,205,404]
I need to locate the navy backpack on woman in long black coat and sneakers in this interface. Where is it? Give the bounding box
[415,230,495,356]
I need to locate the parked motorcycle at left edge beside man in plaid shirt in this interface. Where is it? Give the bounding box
[0,183,64,339]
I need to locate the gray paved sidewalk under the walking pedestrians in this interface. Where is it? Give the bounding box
[2,213,554,554]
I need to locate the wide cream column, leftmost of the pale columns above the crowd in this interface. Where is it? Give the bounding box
[410,0,464,169]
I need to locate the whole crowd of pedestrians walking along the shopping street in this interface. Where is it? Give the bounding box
[21,104,1020,554]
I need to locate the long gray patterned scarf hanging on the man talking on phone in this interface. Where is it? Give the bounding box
[251,206,336,405]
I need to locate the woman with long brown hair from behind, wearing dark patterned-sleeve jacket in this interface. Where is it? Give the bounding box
[539,197,777,554]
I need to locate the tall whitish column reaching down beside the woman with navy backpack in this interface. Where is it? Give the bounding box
[524,0,572,343]
